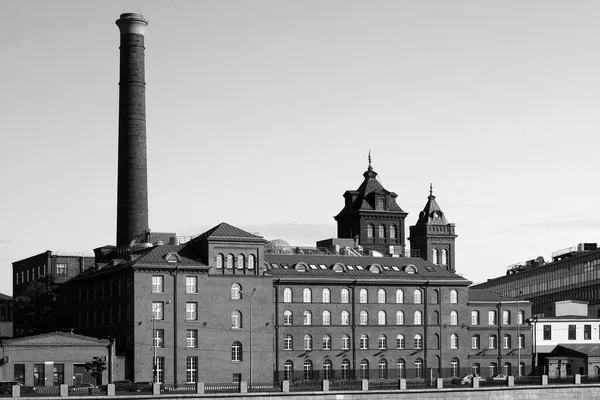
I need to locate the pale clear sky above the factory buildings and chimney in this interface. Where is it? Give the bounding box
[0,0,600,295]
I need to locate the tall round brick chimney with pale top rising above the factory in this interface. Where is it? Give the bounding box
[116,13,148,246]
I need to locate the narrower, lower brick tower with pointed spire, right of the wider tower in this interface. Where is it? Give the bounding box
[408,185,457,272]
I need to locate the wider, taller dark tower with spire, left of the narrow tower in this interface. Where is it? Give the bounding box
[334,151,408,255]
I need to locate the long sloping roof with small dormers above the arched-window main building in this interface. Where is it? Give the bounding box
[264,253,470,285]
